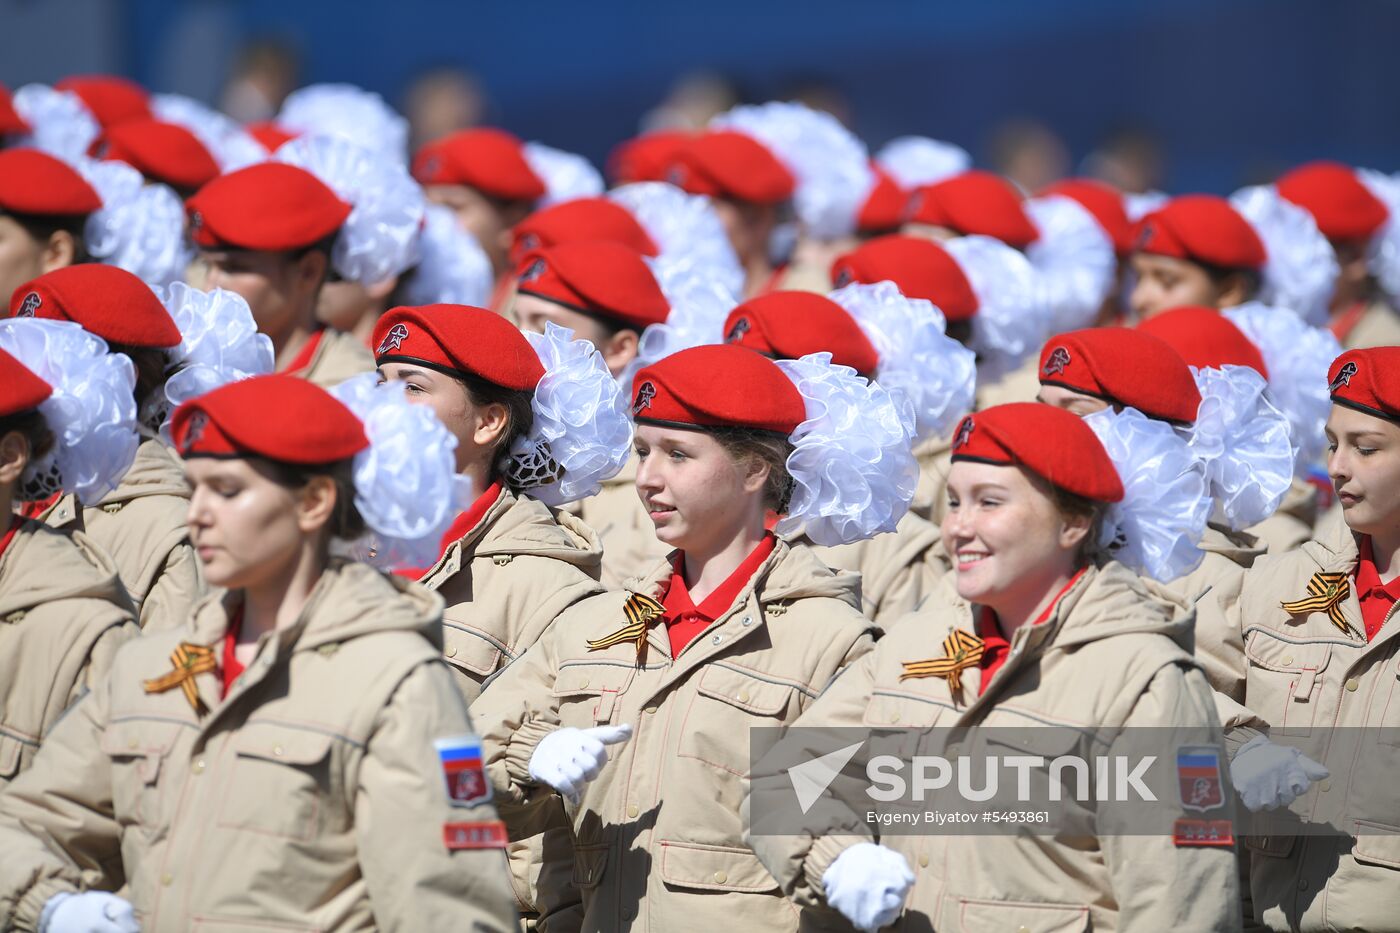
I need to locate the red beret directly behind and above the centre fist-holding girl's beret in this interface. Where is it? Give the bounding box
[724,291,879,378]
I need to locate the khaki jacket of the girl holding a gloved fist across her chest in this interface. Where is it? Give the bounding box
[476,539,874,933]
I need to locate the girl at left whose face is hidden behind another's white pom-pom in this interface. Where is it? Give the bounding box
[10,263,272,630]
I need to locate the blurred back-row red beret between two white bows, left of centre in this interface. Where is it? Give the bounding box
[413,127,545,200]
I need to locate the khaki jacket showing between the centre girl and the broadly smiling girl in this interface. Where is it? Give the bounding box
[802,513,946,632]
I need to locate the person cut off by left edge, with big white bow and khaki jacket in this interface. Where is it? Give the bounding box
[0,321,137,789]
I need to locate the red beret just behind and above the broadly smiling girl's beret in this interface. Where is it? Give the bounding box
[1040,328,1201,424]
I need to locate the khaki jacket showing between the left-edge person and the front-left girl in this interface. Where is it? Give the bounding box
[45,438,206,632]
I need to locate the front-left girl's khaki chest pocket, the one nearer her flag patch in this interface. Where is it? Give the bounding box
[218,720,341,842]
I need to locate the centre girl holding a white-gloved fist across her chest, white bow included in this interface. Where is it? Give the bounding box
[476,346,913,932]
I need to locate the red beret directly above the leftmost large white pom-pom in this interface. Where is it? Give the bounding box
[10,262,182,349]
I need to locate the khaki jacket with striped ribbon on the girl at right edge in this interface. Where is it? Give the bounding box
[1226,509,1400,930]
